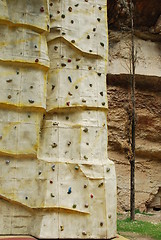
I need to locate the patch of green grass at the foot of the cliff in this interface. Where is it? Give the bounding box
[117,218,161,240]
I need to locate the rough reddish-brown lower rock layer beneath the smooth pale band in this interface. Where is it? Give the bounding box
[108,75,161,210]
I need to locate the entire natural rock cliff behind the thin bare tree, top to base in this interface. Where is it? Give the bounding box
[107,0,161,211]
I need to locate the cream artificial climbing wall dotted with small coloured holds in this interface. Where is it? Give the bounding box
[0,0,116,239]
